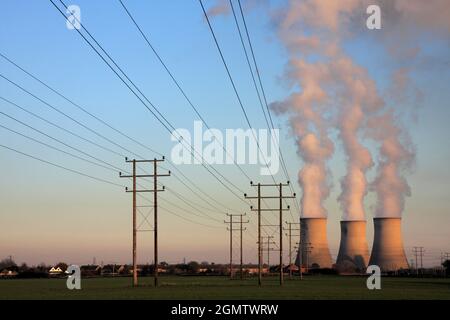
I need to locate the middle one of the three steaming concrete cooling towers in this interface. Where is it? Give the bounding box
[336,221,369,273]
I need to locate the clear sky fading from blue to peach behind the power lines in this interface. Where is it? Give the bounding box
[0,0,450,265]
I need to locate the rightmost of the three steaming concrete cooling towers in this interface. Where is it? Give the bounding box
[369,218,409,271]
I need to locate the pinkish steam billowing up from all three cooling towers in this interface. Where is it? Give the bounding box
[205,0,450,220]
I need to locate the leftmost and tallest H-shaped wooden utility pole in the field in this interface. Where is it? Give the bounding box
[119,157,170,287]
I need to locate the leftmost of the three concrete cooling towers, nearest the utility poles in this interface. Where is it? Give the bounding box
[296,218,332,268]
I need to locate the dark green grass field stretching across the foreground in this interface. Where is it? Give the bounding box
[0,276,450,300]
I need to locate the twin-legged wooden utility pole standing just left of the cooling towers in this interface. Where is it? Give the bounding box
[244,181,295,285]
